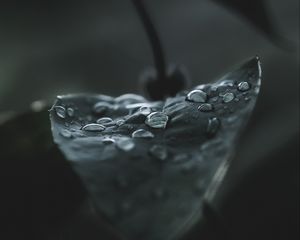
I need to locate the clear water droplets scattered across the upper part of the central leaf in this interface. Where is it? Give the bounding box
[54,80,251,160]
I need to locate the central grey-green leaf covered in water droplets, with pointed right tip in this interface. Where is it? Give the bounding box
[50,57,261,240]
